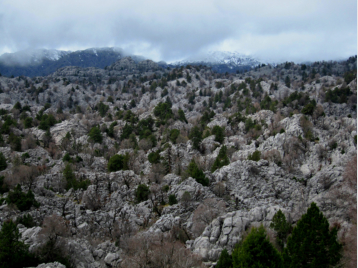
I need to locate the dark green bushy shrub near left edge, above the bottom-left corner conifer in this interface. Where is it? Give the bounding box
[6,184,40,211]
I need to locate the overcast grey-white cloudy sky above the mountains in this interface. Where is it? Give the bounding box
[0,0,357,62]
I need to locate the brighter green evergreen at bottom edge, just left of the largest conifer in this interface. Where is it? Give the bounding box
[232,226,283,268]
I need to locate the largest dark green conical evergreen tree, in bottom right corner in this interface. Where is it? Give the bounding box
[283,203,342,268]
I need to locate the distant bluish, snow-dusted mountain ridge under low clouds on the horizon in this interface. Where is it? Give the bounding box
[0,47,264,77]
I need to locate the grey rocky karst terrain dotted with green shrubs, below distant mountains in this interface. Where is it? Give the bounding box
[0,57,357,268]
